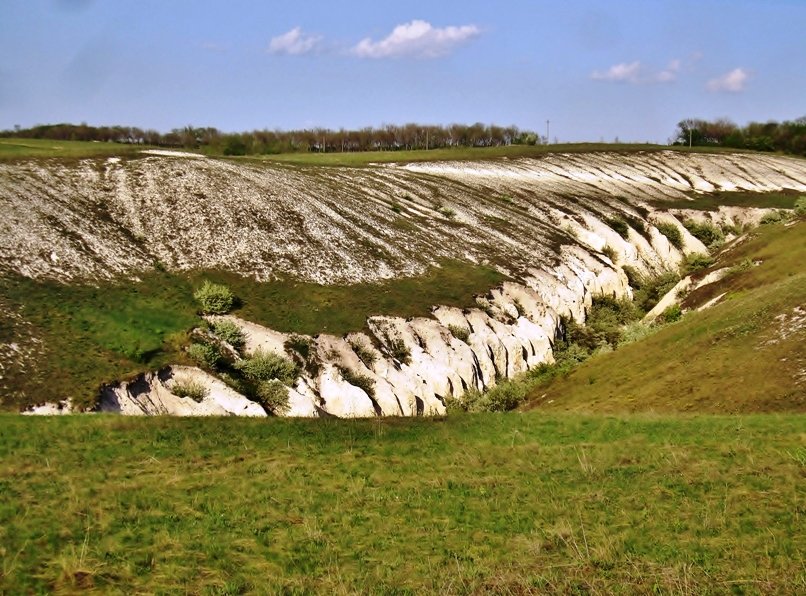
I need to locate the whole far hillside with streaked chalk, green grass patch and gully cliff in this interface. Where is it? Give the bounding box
[0,150,806,416]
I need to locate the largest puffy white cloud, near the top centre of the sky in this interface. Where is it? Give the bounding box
[351,20,481,58]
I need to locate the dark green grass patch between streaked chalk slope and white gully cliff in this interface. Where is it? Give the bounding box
[0,261,503,408]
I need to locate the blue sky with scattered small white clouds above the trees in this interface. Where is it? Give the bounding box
[0,0,806,142]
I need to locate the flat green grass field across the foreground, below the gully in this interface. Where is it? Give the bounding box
[0,413,806,594]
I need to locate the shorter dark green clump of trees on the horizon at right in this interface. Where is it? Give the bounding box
[672,116,806,155]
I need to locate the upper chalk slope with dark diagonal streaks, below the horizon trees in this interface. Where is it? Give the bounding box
[0,151,806,283]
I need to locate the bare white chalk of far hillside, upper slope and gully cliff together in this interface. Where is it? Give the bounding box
[6,152,806,417]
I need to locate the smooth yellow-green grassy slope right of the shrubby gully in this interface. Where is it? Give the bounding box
[532,220,806,412]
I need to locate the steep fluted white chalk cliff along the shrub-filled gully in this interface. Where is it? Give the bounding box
[87,231,681,418]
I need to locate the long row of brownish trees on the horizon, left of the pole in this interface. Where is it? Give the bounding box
[0,123,546,155]
